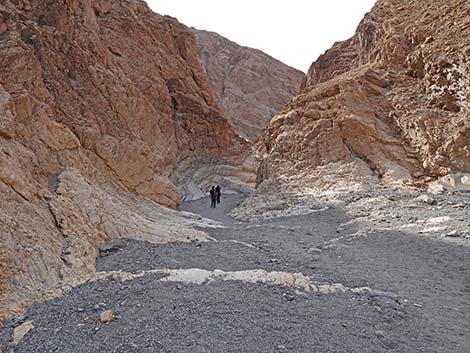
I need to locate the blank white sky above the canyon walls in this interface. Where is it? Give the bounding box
[146,0,375,72]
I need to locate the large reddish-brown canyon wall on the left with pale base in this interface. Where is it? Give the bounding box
[0,0,253,321]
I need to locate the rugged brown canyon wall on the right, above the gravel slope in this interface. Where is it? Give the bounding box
[258,0,470,189]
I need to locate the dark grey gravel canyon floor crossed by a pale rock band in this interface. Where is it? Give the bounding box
[0,196,470,353]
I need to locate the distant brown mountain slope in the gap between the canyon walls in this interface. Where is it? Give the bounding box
[194,30,305,141]
